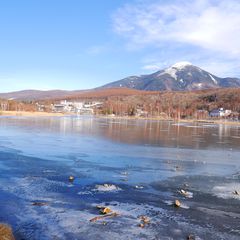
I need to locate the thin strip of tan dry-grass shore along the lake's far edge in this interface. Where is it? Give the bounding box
[0,111,240,126]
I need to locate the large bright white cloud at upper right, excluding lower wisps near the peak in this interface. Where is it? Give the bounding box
[113,0,240,56]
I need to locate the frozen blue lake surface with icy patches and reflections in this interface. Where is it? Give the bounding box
[0,117,240,240]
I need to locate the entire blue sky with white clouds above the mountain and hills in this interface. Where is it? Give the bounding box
[0,0,240,92]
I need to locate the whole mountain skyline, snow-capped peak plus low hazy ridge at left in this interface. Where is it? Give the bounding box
[0,62,240,101]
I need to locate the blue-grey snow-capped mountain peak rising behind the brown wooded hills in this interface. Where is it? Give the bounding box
[103,62,240,91]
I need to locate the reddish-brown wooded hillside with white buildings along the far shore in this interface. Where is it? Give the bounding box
[0,88,240,121]
